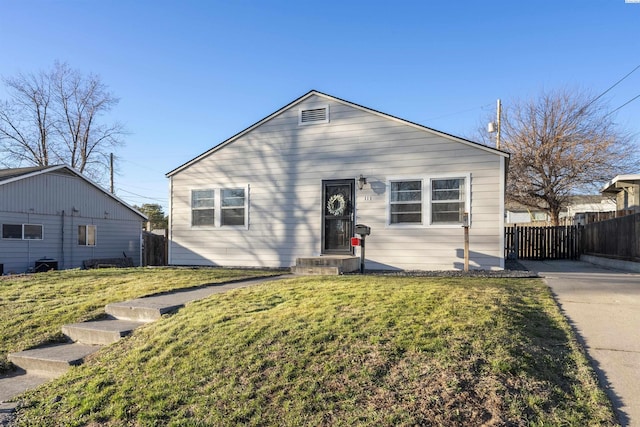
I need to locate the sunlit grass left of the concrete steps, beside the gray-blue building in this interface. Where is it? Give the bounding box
[0,268,277,373]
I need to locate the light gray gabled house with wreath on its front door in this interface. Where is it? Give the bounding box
[167,91,509,270]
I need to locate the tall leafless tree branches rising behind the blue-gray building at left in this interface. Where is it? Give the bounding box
[0,62,125,178]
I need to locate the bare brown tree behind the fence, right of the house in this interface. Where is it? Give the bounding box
[502,90,638,225]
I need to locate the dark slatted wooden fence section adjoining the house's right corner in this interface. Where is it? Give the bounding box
[504,225,581,260]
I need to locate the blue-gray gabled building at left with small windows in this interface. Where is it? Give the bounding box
[0,166,146,274]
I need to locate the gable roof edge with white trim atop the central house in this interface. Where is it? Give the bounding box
[165,90,509,178]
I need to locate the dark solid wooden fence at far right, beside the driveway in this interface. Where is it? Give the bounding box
[582,213,640,262]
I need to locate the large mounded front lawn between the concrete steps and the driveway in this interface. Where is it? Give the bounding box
[3,276,615,426]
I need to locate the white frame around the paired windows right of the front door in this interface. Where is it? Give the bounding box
[386,173,471,228]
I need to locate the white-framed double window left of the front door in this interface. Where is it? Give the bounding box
[191,187,248,227]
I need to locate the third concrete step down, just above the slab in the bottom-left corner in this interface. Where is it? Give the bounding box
[7,343,101,378]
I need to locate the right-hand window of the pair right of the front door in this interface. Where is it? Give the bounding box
[431,178,466,224]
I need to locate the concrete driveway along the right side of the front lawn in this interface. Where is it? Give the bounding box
[521,261,640,427]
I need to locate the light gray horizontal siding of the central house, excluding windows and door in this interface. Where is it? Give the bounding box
[170,96,505,270]
